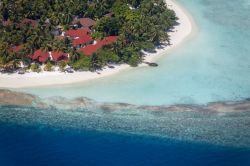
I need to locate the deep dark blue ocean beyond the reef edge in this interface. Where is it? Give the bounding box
[0,124,250,166]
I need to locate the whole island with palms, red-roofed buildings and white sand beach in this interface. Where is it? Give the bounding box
[0,0,193,88]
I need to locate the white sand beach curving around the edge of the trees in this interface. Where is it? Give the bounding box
[0,0,196,88]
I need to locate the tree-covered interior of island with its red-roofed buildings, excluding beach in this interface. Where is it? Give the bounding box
[0,0,177,74]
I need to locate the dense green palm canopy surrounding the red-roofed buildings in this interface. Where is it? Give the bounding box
[0,0,177,70]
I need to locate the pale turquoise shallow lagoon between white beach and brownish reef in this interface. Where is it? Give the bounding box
[20,0,250,105]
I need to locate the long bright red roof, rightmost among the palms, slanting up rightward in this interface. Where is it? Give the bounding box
[79,36,118,56]
